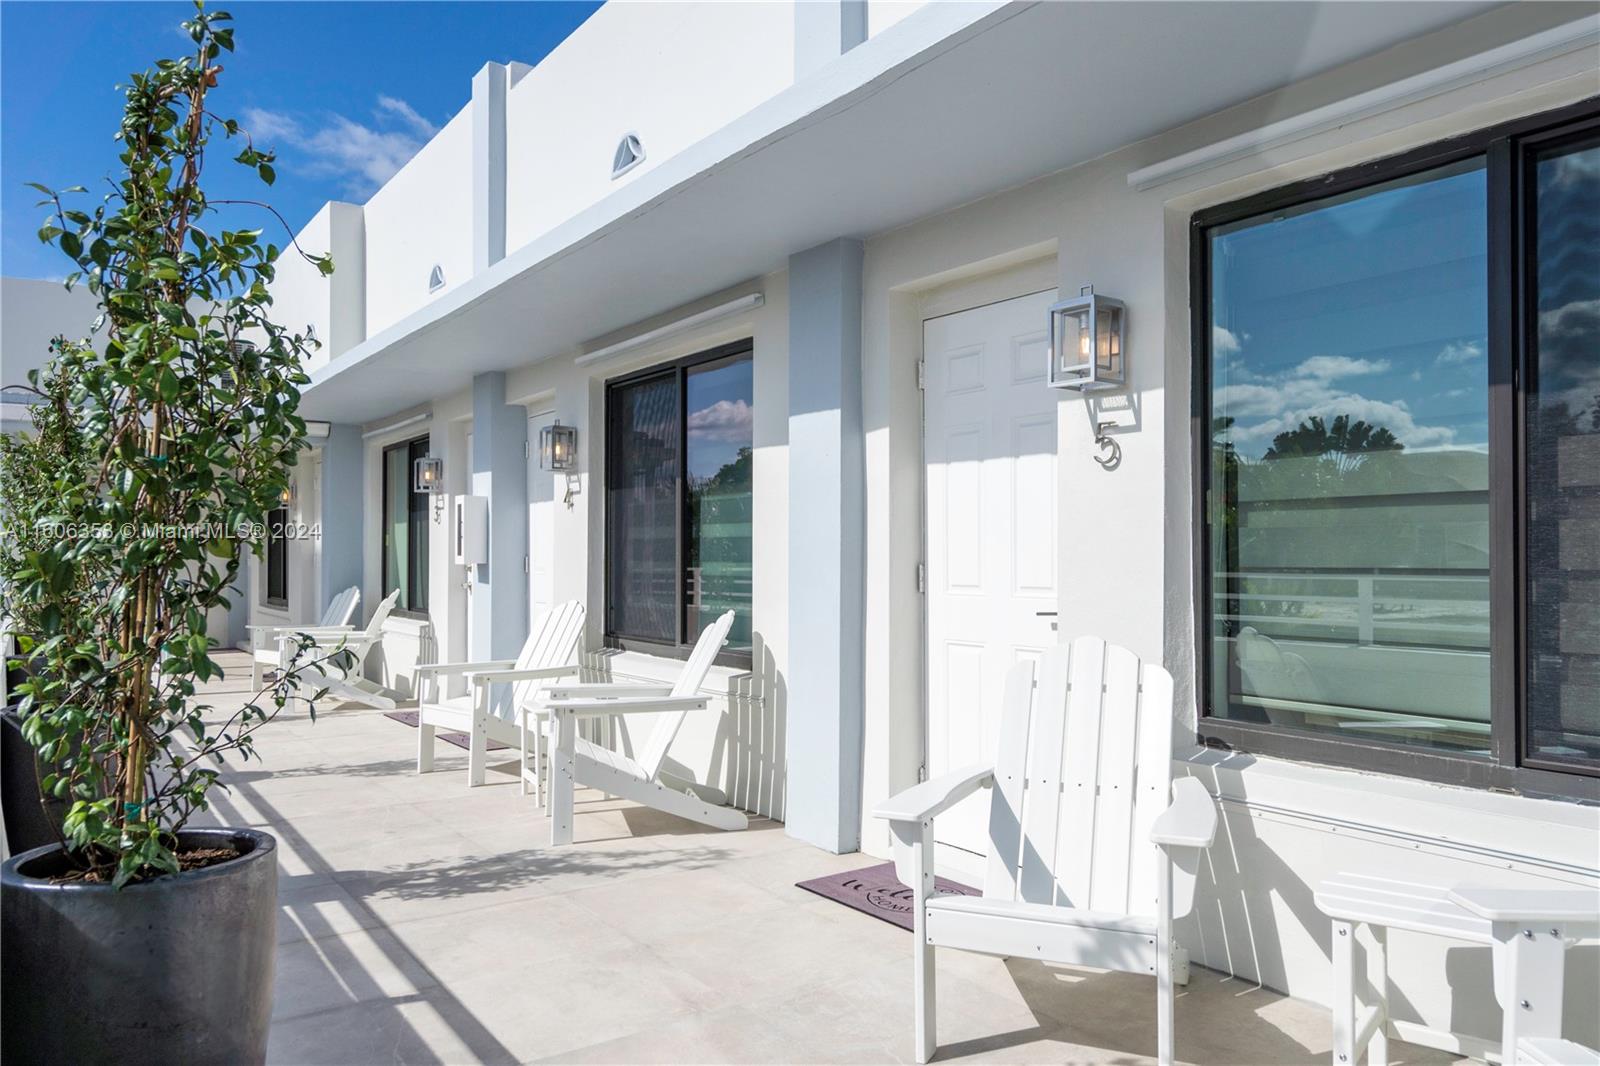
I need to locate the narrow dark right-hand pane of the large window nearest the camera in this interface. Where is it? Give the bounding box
[1526,134,1600,767]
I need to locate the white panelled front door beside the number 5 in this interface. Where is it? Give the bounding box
[923,290,1059,887]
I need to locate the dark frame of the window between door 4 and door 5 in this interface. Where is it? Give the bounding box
[600,338,755,669]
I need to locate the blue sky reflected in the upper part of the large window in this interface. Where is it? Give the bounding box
[1211,160,1488,459]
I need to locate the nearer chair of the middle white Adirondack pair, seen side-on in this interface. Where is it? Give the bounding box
[522,611,749,845]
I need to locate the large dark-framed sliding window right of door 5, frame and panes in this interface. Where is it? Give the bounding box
[1192,106,1600,794]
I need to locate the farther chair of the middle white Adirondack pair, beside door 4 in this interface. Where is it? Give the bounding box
[416,600,584,787]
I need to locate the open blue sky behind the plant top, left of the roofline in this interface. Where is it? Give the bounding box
[0,0,600,277]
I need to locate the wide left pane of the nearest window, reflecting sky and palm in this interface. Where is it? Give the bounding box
[1205,157,1490,754]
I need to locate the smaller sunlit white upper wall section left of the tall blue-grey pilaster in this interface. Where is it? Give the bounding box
[365,104,472,336]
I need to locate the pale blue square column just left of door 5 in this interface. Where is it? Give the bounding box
[786,236,866,853]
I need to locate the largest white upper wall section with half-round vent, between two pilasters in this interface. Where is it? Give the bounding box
[506,0,794,253]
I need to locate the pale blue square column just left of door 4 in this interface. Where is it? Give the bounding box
[467,371,528,659]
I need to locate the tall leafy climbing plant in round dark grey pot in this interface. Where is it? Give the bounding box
[0,5,333,1063]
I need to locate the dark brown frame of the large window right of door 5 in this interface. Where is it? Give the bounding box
[1189,96,1600,802]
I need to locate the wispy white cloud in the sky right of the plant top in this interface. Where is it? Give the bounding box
[243,96,438,198]
